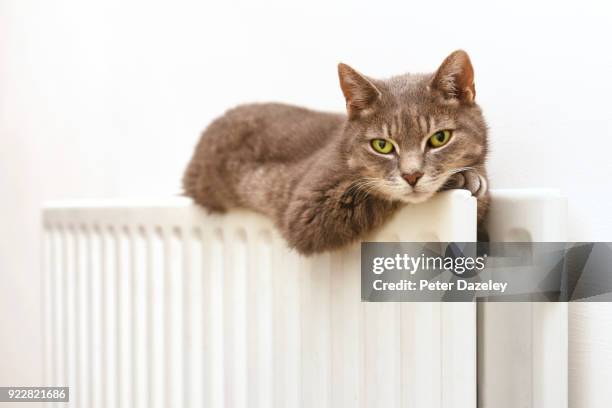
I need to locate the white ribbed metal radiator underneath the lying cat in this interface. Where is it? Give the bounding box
[43,191,567,408]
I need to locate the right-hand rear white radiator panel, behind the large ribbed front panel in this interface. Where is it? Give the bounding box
[478,190,568,408]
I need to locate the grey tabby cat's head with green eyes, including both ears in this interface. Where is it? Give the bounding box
[338,50,487,203]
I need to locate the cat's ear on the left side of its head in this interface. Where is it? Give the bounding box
[338,63,381,117]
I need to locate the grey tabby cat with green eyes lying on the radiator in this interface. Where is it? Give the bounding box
[183,50,489,255]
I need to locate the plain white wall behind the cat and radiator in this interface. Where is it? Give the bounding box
[0,0,612,396]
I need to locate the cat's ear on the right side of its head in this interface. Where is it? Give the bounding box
[431,50,476,103]
